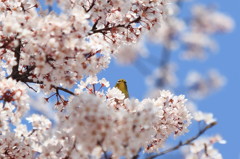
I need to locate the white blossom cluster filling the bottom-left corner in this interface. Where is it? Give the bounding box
[0,112,51,159]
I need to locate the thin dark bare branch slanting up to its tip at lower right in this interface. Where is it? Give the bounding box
[147,122,217,159]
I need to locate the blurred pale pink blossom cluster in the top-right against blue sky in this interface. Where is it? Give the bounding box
[182,5,234,59]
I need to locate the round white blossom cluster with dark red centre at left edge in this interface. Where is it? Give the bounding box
[0,78,29,126]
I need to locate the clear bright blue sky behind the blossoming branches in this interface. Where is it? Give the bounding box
[100,0,240,159]
